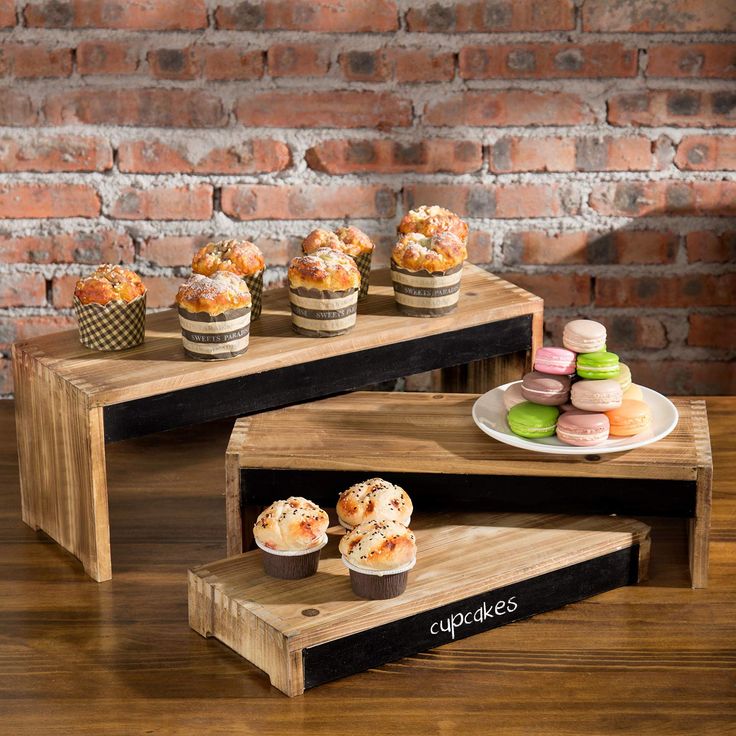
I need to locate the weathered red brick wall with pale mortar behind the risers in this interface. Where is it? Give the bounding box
[0,0,736,394]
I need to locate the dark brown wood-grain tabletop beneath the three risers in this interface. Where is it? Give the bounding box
[0,398,736,736]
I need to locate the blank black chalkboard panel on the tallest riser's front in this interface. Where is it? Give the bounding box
[104,315,532,442]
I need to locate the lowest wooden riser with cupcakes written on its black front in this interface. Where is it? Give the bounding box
[189,513,649,696]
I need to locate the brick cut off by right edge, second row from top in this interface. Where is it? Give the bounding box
[647,43,736,79]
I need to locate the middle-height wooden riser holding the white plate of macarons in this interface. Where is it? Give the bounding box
[226,392,713,588]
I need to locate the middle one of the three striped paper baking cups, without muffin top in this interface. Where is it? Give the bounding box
[289,286,358,337]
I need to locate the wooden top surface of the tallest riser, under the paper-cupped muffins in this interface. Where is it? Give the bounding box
[10,264,543,406]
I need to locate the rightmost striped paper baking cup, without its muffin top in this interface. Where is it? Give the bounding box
[391,260,463,317]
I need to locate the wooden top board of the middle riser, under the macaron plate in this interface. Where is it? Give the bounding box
[236,391,710,480]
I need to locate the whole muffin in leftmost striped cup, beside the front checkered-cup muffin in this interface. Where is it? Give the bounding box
[176,271,251,360]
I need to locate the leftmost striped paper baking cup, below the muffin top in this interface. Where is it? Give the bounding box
[179,307,250,360]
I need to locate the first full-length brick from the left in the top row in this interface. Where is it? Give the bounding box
[24,0,207,31]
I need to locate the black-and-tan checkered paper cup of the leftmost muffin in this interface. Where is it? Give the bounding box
[74,294,146,351]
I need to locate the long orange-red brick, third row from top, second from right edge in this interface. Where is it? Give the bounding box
[424,90,595,127]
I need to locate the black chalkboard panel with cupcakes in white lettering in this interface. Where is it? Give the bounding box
[302,545,639,689]
